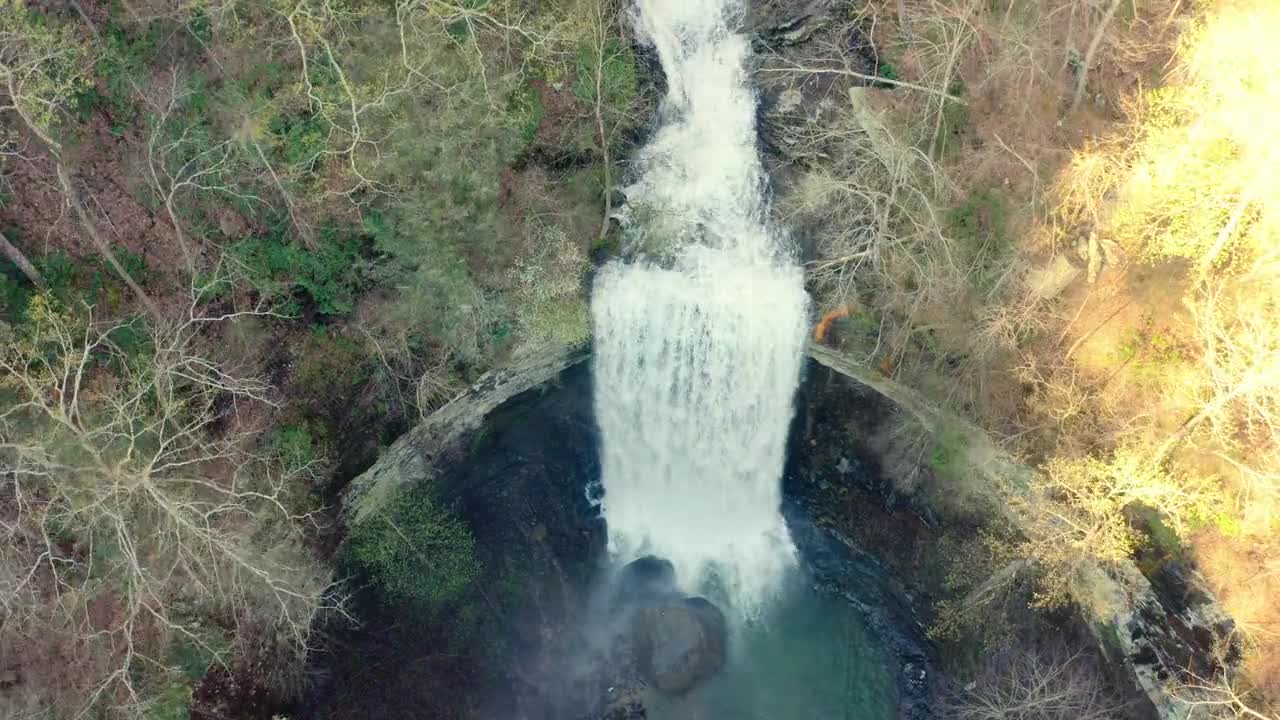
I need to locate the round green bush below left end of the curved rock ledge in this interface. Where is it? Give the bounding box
[346,486,480,615]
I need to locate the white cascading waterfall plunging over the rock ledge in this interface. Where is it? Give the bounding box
[591,0,808,610]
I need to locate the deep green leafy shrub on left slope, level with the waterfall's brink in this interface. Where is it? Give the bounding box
[230,224,369,315]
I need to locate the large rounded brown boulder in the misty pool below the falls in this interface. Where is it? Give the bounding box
[631,597,727,694]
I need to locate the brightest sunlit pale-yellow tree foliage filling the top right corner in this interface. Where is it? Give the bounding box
[1059,0,1280,270]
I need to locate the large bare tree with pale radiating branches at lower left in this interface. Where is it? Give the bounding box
[0,283,333,711]
